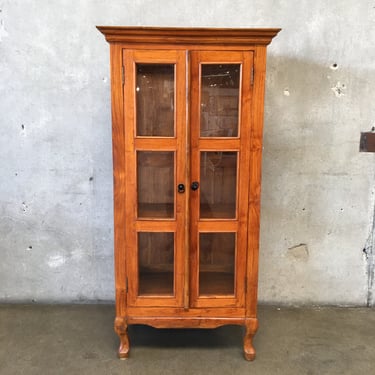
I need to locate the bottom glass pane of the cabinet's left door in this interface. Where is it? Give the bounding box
[138,232,174,296]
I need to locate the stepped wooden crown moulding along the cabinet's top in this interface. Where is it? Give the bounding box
[97,26,281,46]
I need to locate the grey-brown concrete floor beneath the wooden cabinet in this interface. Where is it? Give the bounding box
[0,305,375,375]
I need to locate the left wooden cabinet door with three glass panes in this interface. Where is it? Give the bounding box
[123,50,187,307]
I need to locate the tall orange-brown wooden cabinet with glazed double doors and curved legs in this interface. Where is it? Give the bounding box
[98,26,279,360]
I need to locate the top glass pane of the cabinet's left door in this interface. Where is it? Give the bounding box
[136,64,174,137]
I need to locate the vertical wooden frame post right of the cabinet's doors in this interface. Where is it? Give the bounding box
[246,47,266,317]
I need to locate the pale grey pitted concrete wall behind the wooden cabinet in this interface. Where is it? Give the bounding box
[0,0,375,305]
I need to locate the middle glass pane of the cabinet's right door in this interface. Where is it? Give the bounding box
[200,151,237,219]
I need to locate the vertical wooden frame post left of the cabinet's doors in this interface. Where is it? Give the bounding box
[110,44,126,316]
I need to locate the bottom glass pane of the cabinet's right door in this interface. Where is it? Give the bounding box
[199,233,236,295]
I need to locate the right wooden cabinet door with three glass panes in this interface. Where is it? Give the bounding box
[190,51,253,307]
